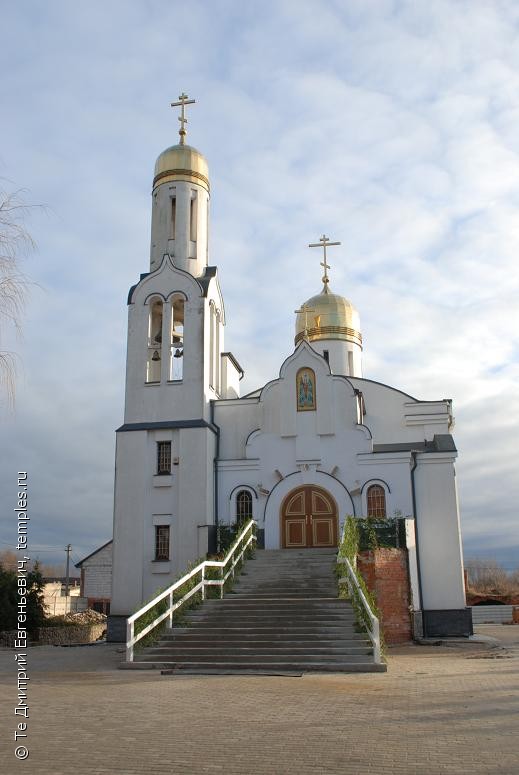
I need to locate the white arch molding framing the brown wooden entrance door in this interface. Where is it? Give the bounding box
[264,469,355,549]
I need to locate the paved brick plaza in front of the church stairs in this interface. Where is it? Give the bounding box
[0,626,519,775]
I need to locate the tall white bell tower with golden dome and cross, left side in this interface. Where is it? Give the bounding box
[109,94,243,640]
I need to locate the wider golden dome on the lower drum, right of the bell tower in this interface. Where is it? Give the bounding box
[294,284,362,347]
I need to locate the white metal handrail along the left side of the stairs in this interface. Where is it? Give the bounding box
[126,519,256,662]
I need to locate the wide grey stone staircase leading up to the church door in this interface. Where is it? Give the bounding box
[133,549,386,674]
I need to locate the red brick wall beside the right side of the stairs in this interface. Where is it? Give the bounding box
[357,549,412,644]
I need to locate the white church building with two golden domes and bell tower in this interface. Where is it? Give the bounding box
[109,95,471,640]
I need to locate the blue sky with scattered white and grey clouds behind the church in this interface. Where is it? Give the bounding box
[0,0,519,567]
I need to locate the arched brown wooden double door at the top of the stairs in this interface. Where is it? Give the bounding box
[281,485,337,549]
